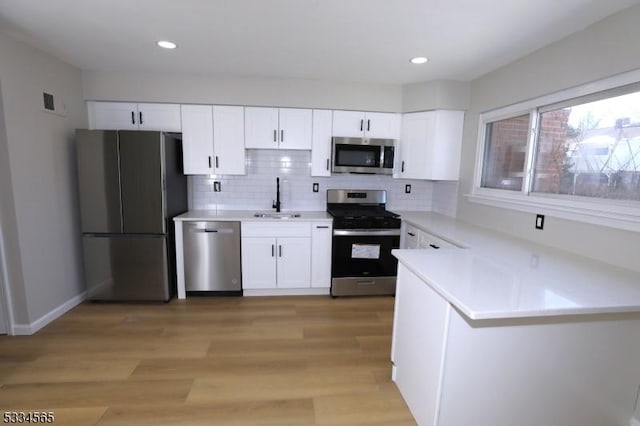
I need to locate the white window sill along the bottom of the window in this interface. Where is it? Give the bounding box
[465,189,640,232]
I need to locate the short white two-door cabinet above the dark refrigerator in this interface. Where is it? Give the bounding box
[87,101,181,132]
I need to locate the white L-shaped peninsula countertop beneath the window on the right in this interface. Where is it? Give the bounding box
[393,212,640,320]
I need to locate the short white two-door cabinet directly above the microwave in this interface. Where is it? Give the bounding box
[333,111,400,139]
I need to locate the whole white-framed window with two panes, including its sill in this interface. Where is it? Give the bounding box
[470,71,640,230]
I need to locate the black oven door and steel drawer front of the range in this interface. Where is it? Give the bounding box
[331,229,400,296]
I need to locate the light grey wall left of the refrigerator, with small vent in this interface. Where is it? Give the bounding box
[0,34,87,332]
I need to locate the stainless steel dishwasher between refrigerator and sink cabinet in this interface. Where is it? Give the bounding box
[182,221,242,295]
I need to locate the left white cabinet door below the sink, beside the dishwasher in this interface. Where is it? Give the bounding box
[242,237,277,289]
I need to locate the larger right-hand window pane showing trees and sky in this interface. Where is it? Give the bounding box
[532,87,640,201]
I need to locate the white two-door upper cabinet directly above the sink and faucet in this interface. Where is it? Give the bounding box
[245,107,313,149]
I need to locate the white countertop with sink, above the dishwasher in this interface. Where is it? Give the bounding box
[173,210,333,222]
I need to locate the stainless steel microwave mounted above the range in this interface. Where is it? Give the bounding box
[331,137,395,175]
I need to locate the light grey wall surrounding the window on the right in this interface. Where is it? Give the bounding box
[457,6,640,270]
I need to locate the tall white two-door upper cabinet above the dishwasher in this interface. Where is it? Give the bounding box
[182,105,246,175]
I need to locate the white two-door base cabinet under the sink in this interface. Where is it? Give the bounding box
[242,222,311,290]
